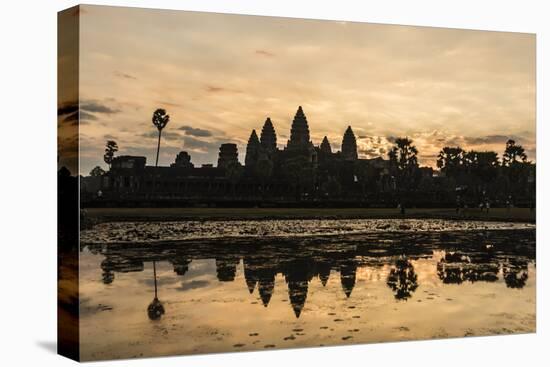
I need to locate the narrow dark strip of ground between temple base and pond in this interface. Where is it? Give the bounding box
[85,208,536,223]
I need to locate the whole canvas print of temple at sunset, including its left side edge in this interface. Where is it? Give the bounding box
[58,5,536,361]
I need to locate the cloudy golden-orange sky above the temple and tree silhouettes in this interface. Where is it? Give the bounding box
[60,6,536,173]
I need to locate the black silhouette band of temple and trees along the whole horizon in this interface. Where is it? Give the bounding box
[80,106,535,207]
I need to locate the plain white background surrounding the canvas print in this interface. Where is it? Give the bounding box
[0,0,550,367]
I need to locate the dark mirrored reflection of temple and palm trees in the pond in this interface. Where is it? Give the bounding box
[87,230,535,319]
